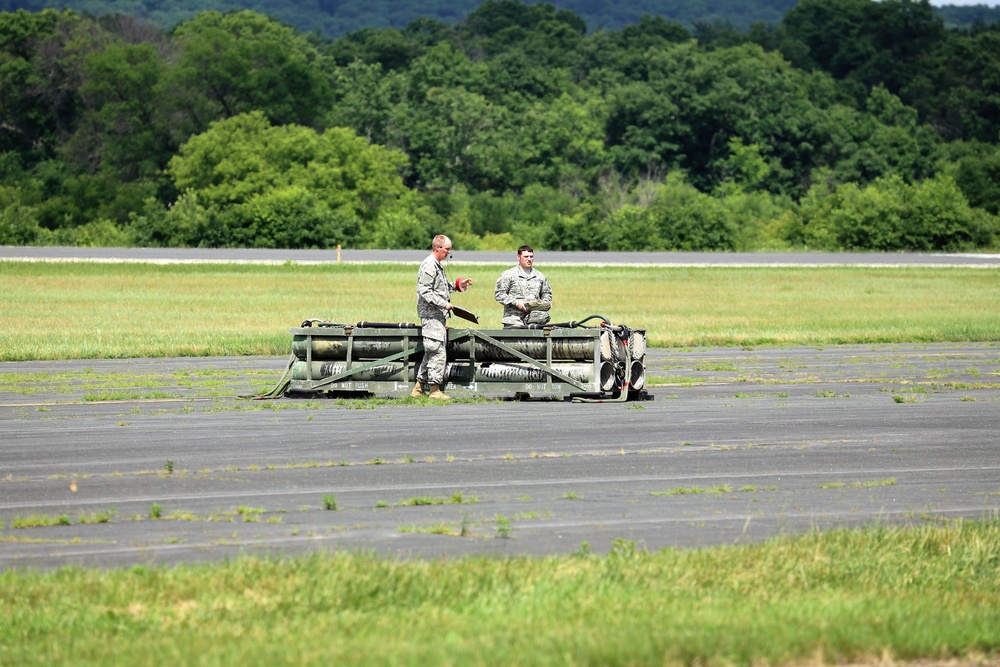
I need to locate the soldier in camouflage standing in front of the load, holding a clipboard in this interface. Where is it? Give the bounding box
[410,234,472,401]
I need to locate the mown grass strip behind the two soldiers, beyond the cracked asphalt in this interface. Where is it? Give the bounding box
[0,262,1000,361]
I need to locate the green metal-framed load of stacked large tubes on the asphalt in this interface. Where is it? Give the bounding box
[262,315,652,402]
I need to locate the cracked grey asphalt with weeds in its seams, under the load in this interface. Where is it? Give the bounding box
[0,343,1000,569]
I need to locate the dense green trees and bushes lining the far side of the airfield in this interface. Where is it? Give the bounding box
[0,0,1000,251]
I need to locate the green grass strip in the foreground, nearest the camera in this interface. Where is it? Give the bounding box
[0,521,1000,667]
